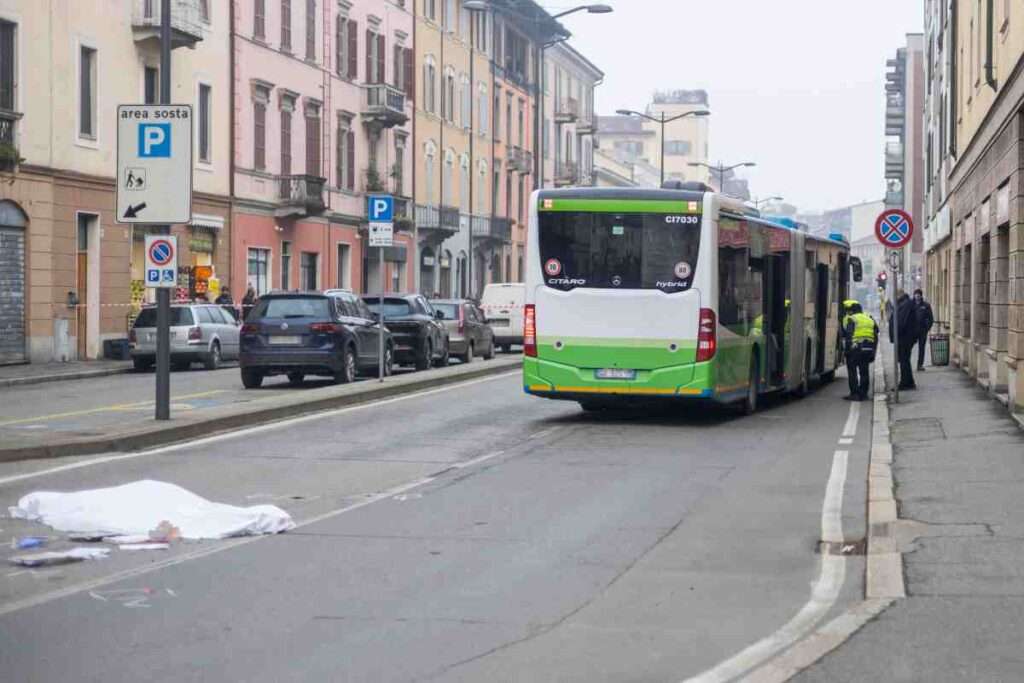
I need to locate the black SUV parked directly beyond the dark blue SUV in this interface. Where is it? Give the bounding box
[362,294,451,370]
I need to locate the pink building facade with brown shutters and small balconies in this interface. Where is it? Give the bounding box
[231,0,416,299]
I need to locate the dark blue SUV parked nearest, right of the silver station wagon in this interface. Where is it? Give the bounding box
[240,292,395,389]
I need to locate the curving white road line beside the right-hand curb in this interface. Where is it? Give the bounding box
[685,403,860,683]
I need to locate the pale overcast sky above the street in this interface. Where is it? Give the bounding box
[557,0,924,211]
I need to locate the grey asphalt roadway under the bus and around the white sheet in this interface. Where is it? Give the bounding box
[0,375,869,681]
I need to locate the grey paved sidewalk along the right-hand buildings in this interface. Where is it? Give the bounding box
[795,345,1024,681]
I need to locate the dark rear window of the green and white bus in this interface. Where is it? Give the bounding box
[540,212,700,292]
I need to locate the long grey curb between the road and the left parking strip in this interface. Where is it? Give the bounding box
[0,358,521,463]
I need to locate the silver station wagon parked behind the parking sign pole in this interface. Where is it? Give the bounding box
[128,304,239,370]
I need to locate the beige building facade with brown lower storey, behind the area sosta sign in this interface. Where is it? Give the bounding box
[0,0,231,362]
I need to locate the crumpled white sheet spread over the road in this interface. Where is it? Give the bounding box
[10,480,295,539]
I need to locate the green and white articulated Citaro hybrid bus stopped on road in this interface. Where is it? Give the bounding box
[523,181,860,413]
